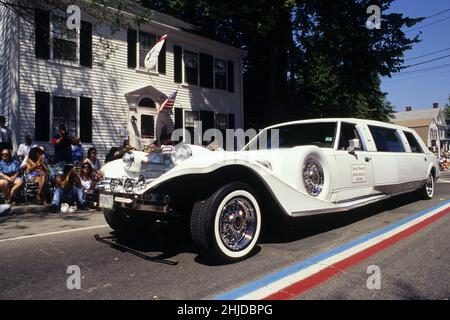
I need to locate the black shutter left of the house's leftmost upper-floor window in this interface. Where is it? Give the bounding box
[34,9,50,59]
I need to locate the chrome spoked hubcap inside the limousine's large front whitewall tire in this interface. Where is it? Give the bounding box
[219,197,256,251]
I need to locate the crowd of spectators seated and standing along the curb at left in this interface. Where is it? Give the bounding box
[0,116,139,212]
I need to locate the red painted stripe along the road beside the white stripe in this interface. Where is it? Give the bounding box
[264,208,450,300]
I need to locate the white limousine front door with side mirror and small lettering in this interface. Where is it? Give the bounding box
[333,122,374,202]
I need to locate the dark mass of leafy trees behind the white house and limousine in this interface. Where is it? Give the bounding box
[144,0,421,127]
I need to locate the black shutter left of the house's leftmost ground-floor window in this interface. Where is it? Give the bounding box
[34,91,50,141]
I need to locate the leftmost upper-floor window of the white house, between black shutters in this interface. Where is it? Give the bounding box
[52,15,78,62]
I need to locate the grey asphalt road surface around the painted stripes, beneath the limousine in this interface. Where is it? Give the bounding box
[0,175,450,300]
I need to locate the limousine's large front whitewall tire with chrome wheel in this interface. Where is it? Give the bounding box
[191,183,262,262]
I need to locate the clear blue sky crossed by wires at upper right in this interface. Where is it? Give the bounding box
[381,0,450,111]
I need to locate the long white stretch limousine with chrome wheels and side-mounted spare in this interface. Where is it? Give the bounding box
[99,119,440,262]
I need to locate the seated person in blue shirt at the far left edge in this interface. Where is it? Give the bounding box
[0,149,23,204]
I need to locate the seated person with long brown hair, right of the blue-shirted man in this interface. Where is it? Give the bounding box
[26,147,50,205]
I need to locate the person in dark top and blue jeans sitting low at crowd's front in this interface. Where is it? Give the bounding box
[50,165,91,213]
